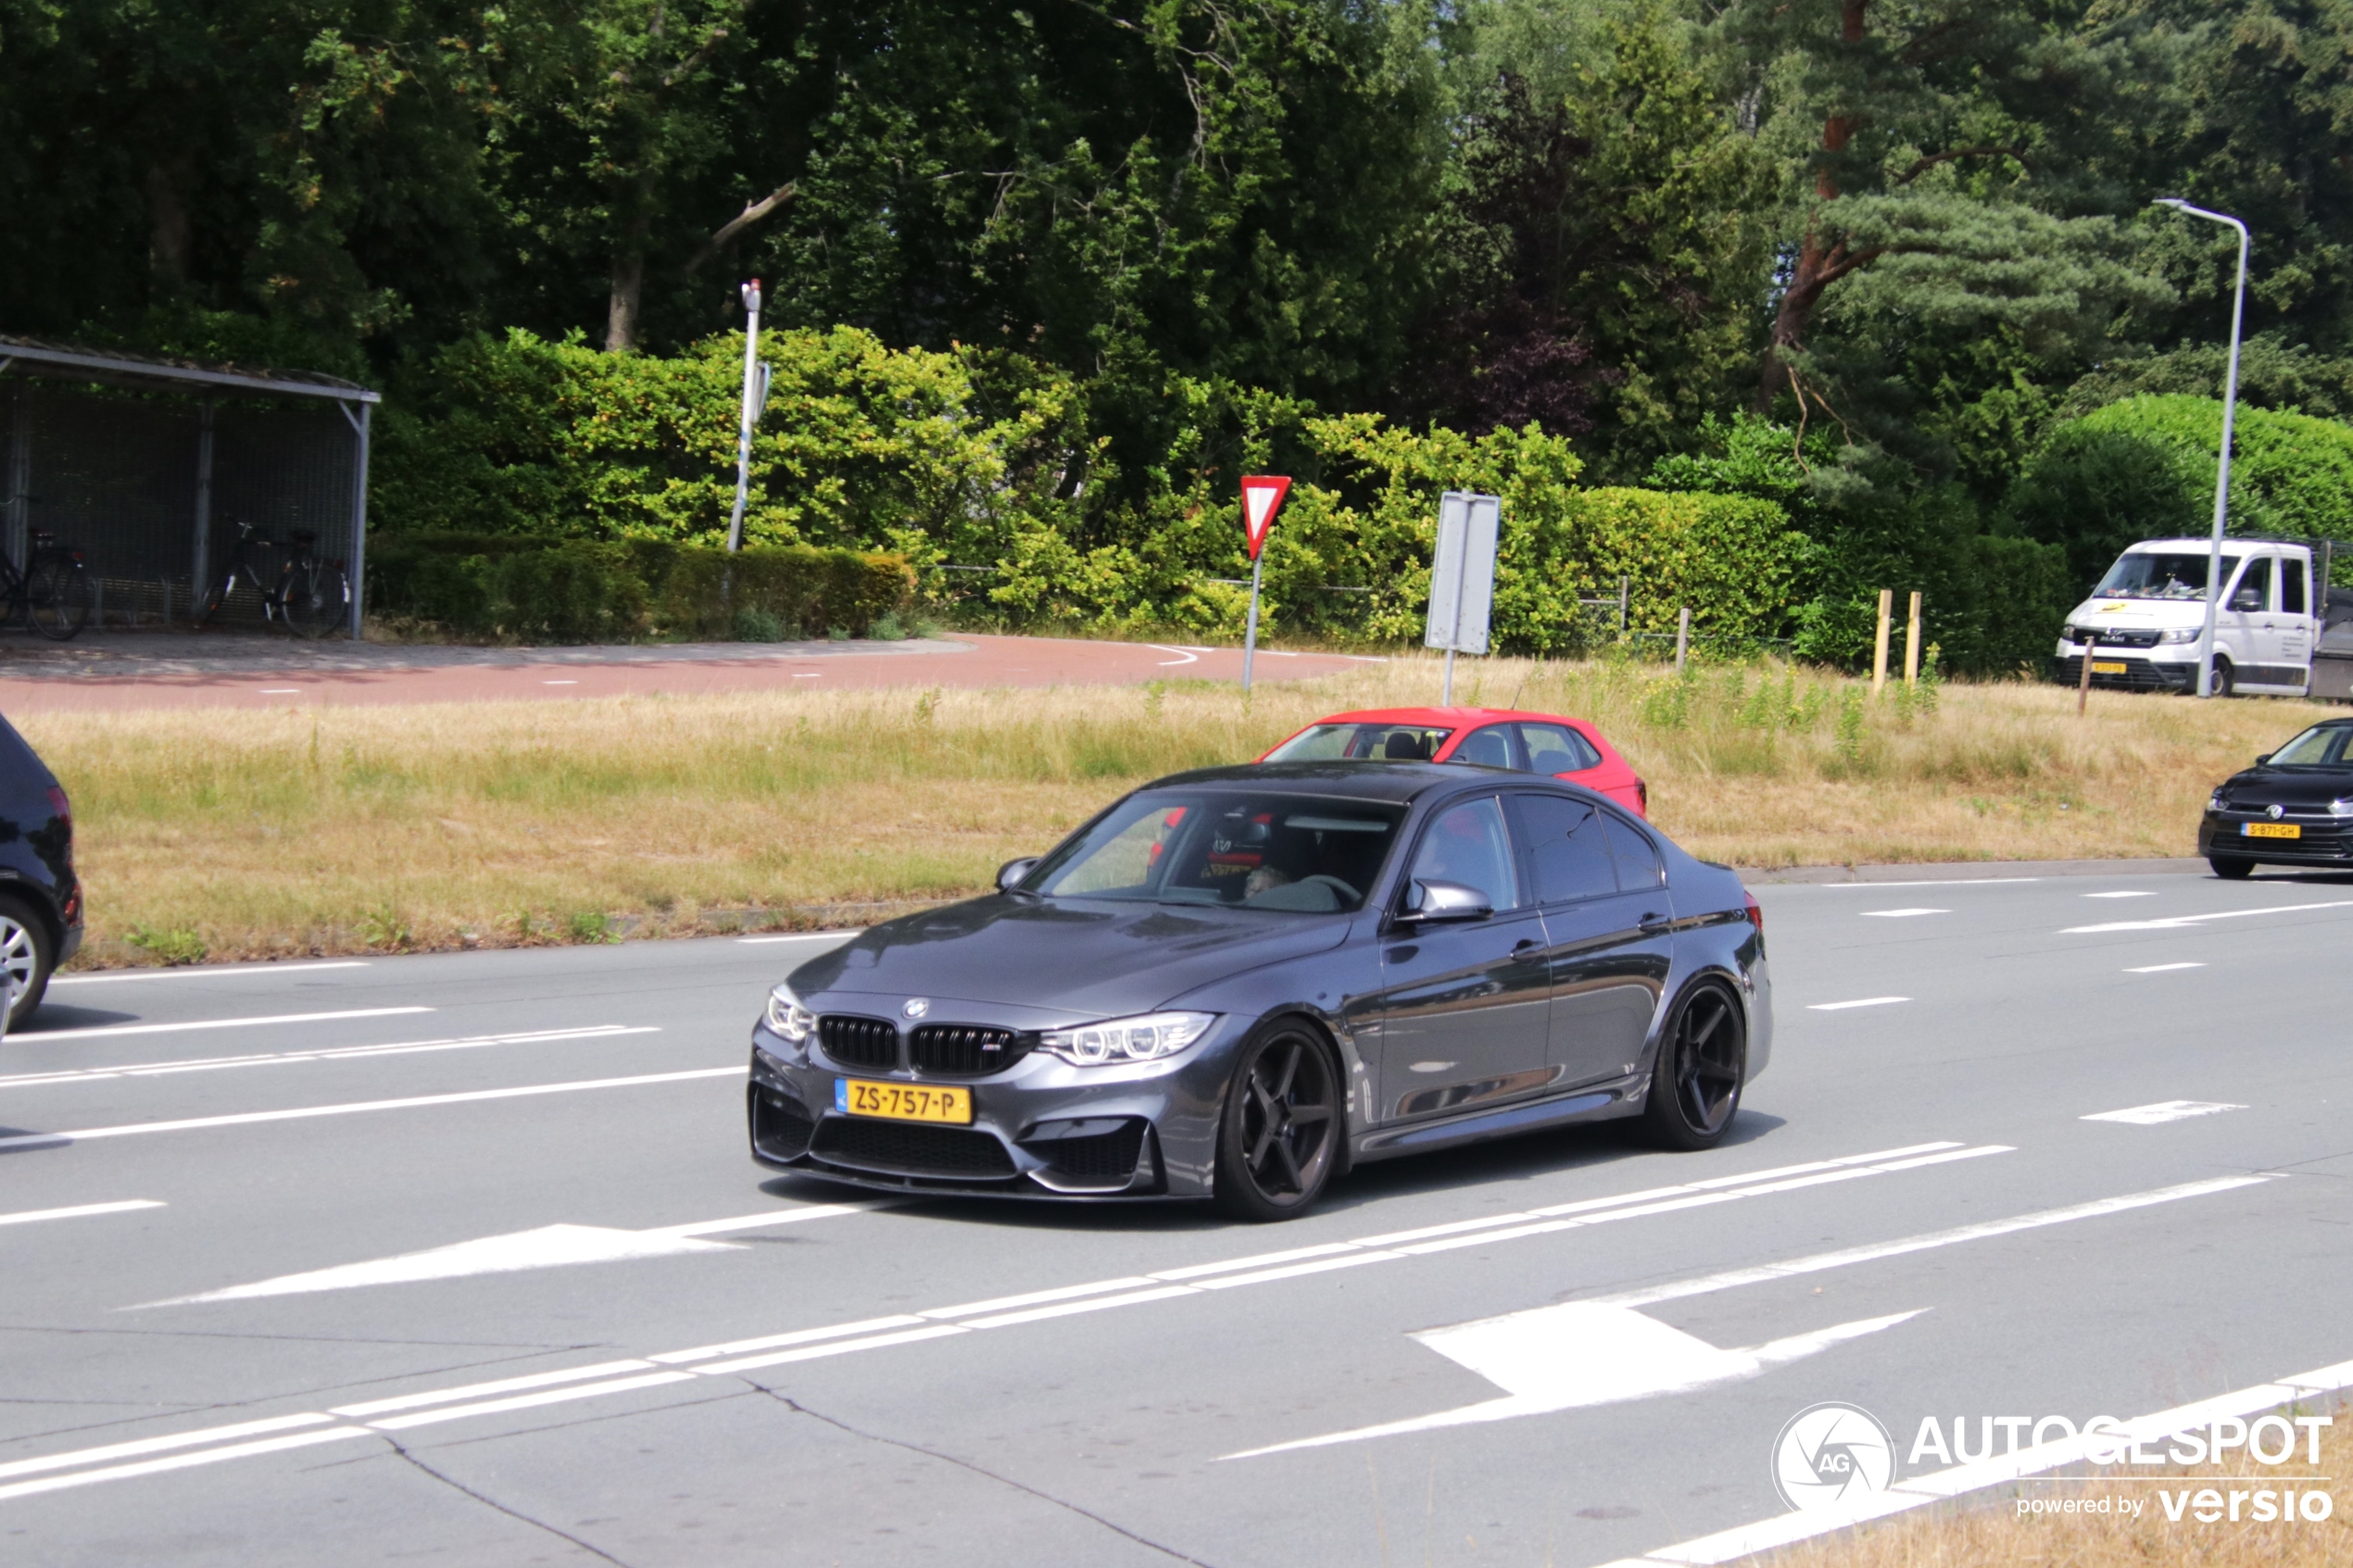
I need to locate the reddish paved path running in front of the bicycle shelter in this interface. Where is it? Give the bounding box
[0,633,1378,717]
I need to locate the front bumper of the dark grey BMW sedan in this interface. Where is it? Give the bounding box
[744,1018,1240,1198]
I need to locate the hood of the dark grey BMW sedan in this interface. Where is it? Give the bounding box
[790,894,1355,1027]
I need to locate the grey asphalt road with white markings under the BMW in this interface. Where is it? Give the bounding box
[0,874,2353,1568]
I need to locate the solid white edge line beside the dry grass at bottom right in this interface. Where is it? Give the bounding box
[1607,1361,2353,1568]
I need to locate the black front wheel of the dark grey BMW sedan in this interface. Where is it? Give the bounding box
[1216,1021,1346,1220]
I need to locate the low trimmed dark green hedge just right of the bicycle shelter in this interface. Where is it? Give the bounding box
[367,533,915,642]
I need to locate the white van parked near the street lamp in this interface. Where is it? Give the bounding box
[2057,538,2327,696]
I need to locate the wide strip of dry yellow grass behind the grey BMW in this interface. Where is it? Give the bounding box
[23,659,2327,961]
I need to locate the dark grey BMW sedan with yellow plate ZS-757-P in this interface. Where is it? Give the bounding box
[749,761,1772,1220]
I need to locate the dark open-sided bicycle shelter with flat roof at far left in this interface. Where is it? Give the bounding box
[0,336,379,637]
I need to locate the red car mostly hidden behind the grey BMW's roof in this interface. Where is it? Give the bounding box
[1259,708,1650,816]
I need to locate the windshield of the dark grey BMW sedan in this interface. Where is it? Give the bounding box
[1021,790,1404,914]
